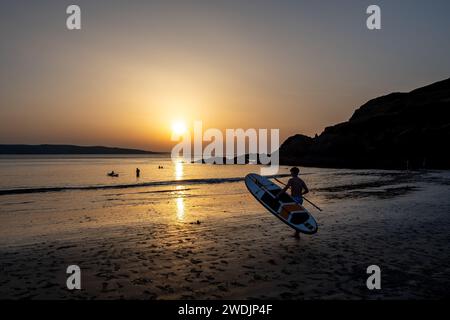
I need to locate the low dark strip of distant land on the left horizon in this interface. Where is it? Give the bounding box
[0,144,161,154]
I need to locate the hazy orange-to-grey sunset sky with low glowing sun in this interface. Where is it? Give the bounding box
[0,0,450,151]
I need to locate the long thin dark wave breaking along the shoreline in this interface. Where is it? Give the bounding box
[0,174,289,196]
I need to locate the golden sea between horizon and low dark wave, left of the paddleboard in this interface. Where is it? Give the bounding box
[0,155,259,190]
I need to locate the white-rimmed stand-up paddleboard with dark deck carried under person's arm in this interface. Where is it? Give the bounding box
[245,173,318,234]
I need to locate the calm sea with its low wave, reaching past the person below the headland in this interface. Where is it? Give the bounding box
[0,155,424,194]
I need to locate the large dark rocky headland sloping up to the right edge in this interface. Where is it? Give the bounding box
[280,79,450,169]
